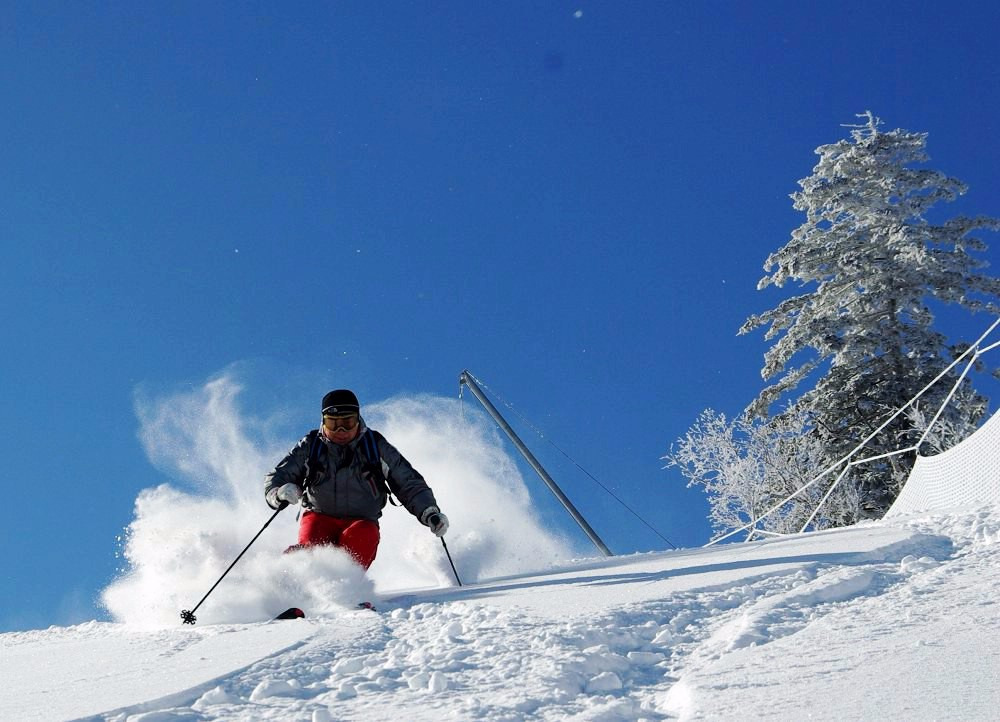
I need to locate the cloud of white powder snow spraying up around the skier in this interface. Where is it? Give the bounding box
[102,374,574,627]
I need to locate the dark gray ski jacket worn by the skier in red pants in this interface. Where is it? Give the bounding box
[264,420,437,522]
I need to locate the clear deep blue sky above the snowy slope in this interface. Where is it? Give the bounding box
[0,2,1000,630]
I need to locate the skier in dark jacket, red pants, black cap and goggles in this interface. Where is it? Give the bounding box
[264,389,448,569]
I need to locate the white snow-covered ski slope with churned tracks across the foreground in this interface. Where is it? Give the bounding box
[0,506,1000,722]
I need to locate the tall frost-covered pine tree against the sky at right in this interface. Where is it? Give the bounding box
[740,112,1000,522]
